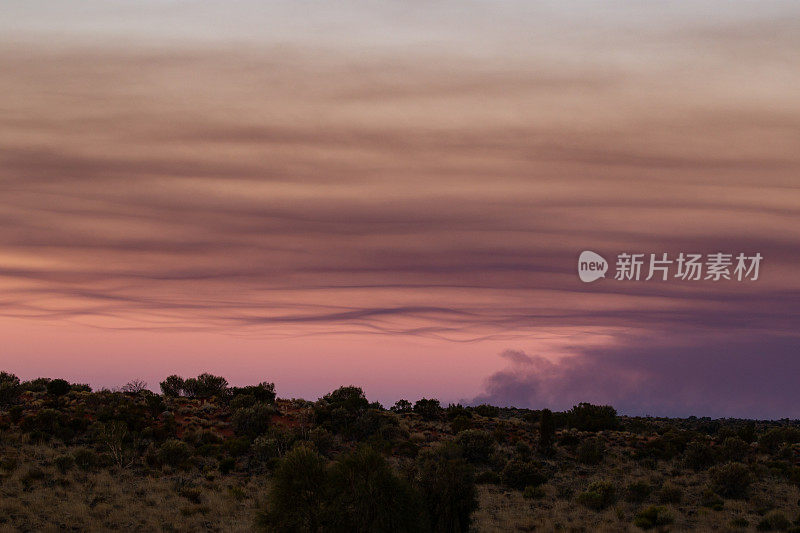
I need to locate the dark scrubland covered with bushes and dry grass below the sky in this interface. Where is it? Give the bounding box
[0,372,800,533]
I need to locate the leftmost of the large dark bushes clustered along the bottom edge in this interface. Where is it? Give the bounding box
[256,446,329,533]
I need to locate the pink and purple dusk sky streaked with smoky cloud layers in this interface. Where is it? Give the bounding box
[0,0,800,418]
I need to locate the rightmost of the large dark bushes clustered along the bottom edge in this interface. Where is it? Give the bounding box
[416,445,478,533]
